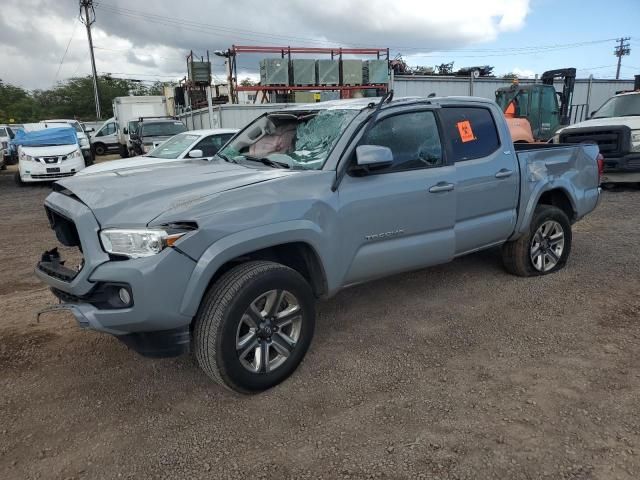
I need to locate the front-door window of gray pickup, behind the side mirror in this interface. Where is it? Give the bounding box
[354,111,444,173]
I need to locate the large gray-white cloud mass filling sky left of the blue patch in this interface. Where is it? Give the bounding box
[0,0,530,88]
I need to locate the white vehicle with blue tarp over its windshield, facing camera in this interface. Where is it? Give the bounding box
[14,123,85,186]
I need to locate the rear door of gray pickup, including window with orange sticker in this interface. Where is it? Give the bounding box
[439,106,520,255]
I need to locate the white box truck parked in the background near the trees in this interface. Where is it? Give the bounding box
[113,95,168,158]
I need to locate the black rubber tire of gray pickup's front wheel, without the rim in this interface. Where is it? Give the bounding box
[193,261,315,393]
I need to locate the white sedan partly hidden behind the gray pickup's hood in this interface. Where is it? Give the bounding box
[78,128,238,175]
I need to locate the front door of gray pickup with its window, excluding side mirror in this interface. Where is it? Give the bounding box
[339,109,456,285]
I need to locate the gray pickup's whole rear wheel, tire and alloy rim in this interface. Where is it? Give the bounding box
[502,205,572,277]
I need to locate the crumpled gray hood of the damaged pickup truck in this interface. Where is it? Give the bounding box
[56,160,292,227]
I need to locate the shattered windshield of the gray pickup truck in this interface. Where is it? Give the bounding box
[220,110,359,170]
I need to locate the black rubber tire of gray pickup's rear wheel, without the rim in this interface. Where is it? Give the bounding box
[502,205,572,277]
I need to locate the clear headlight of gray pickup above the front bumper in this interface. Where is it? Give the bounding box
[100,228,187,258]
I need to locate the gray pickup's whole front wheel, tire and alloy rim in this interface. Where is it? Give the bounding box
[193,261,315,393]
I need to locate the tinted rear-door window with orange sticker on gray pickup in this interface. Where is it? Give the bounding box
[440,107,500,162]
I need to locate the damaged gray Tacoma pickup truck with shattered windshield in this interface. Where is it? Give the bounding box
[36,96,601,393]
